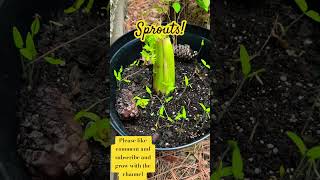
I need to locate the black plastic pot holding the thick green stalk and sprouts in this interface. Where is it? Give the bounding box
[110,25,211,150]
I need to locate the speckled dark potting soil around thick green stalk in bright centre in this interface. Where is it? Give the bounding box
[117,59,210,148]
